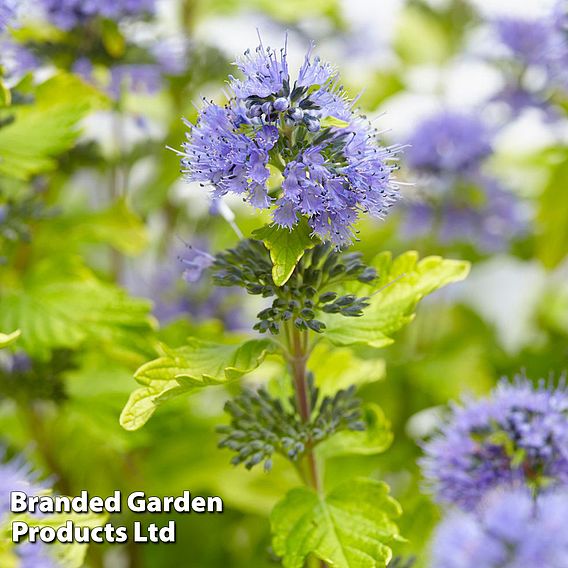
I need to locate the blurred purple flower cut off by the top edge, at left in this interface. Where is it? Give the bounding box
[40,0,155,30]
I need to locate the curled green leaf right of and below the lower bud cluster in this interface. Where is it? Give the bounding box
[317,403,393,459]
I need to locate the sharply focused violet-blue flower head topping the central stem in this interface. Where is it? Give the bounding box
[181,40,398,246]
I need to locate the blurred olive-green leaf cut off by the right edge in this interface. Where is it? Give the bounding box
[537,150,568,268]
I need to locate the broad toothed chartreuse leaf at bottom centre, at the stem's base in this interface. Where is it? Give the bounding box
[270,478,401,568]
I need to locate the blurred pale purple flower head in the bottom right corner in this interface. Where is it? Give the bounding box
[432,489,568,568]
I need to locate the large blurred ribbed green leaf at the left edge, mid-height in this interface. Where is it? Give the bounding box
[0,256,153,358]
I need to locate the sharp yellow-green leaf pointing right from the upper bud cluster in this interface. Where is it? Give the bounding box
[322,251,469,348]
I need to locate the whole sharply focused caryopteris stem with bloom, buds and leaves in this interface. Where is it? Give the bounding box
[121,37,468,568]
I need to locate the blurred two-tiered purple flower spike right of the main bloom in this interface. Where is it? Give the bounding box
[405,110,526,250]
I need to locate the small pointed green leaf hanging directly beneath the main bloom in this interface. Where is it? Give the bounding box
[253,219,317,286]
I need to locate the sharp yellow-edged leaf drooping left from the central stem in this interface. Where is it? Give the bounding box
[120,337,276,430]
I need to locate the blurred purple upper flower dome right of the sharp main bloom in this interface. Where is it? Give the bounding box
[405,111,492,176]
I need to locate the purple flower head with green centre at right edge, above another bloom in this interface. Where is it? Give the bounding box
[421,378,568,508]
